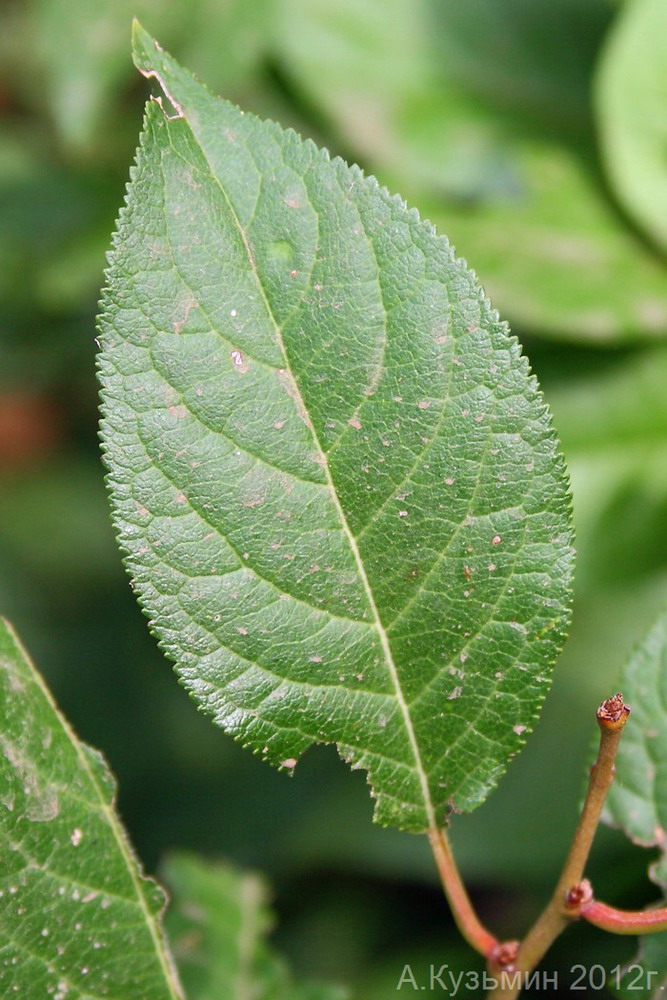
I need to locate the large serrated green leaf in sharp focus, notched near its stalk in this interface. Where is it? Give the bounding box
[100,29,572,830]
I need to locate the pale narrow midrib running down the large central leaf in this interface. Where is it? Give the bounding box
[177,115,438,831]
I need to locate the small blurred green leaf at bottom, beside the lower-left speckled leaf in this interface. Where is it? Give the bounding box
[164,854,346,1000]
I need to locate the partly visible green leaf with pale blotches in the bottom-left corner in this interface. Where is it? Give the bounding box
[0,623,181,1000]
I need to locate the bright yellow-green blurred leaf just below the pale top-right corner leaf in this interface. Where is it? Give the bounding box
[425,138,667,344]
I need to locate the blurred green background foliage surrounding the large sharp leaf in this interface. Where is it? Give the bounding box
[0,0,667,1000]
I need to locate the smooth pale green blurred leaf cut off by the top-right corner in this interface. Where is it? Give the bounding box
[597,0,667,250]
